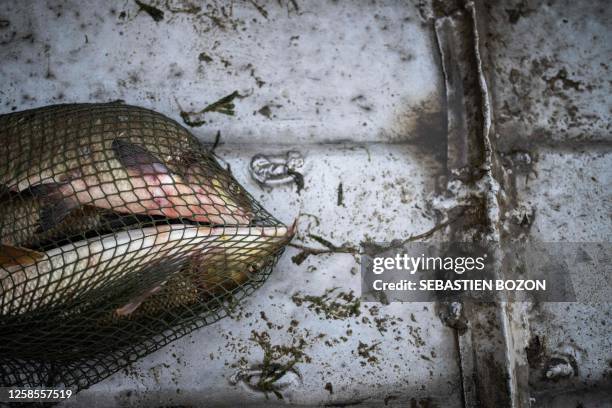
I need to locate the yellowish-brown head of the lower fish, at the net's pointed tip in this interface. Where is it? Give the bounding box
[115,223,295,318]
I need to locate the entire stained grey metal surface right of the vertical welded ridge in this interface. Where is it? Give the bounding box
[485,1,612,407]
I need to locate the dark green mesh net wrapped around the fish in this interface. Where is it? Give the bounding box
[0,104,293,389]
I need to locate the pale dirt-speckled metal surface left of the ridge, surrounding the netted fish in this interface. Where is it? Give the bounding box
[0,0,461,406]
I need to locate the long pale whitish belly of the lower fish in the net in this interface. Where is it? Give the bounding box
[0,217,292,316]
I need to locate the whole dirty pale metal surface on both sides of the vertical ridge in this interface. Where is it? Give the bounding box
[0,0,612,407]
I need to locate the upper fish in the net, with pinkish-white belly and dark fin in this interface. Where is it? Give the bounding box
[0,103,254,231]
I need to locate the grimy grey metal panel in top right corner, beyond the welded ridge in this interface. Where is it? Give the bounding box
[485,0,612,149]
